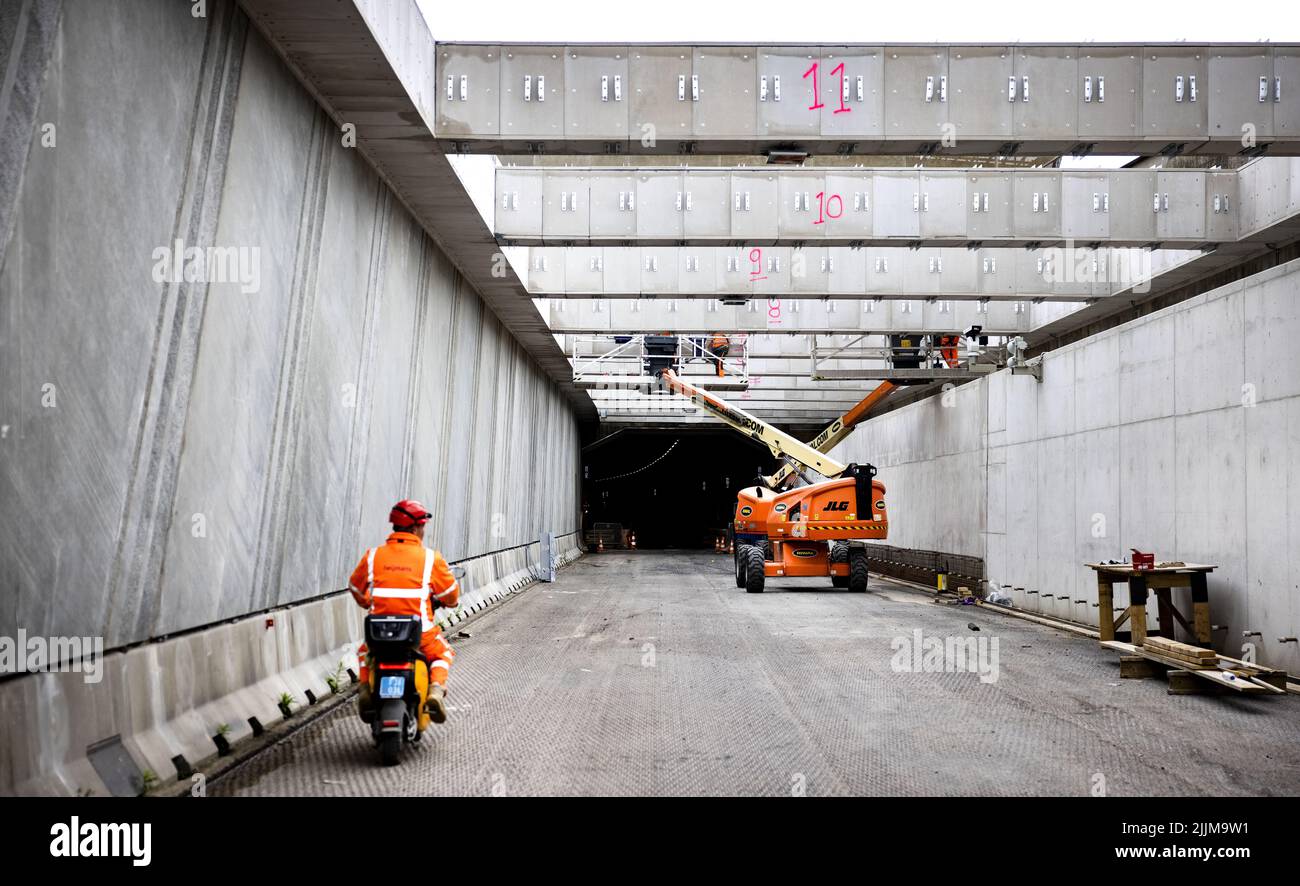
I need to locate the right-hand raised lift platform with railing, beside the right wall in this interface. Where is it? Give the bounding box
[810,333,1006,382]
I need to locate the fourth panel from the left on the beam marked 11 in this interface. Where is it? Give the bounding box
[627,45,694,145]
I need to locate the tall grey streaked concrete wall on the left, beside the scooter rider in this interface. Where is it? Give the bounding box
[0,0,580,791]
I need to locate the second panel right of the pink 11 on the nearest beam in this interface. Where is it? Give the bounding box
[948,45,1021,144]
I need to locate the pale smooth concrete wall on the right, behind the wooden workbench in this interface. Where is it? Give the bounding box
[840,261,1300,673]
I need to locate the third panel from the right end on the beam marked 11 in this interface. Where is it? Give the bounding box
[1076,47,1143,146]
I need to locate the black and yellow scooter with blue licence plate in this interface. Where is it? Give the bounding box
[360,616,429,766]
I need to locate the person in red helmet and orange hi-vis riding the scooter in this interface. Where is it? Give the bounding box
[348,499,460,722]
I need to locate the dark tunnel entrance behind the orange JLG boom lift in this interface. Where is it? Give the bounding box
[582,429,777,548]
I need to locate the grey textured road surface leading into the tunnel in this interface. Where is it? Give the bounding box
[211,551,1300,796]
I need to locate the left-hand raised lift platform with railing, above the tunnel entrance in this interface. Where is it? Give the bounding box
[571,333,749,391]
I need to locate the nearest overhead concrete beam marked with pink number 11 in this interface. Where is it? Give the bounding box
[434,43,1300,155]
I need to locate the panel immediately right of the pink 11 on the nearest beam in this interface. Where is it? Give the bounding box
[884,47,952,144]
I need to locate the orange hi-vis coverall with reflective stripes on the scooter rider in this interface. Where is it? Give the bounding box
[348,533,460,687]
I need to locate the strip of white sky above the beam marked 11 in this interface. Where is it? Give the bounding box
[416,0,1300,43]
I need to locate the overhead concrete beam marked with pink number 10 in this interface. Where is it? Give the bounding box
[495,160,1248,248]
